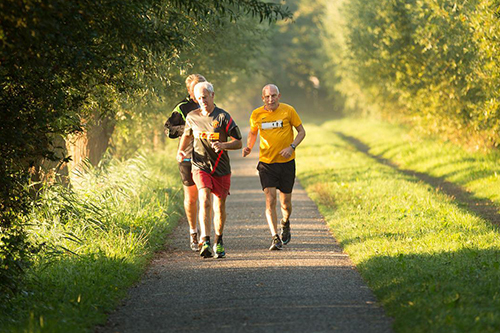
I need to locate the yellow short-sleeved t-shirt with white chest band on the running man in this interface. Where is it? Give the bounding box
[250,103,302,163]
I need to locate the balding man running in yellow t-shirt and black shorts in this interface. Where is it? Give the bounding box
[243,84,306,250]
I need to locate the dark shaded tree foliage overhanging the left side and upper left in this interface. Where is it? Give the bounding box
[0,0,290,295]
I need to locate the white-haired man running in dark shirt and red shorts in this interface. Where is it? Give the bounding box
[177,82,242,258]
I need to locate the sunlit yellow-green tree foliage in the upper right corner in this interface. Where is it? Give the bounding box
[329,0,500,147]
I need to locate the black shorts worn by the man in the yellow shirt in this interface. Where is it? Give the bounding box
[257,160,295,193]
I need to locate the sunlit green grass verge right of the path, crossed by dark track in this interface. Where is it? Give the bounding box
[297,119,500,332]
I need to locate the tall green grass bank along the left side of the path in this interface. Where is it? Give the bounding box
[0,147,182,332]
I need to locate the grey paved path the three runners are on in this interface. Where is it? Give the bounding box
[97,147,391,332]
